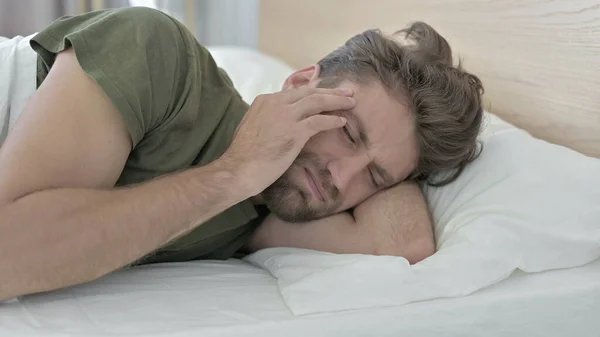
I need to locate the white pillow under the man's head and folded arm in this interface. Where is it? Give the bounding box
[246,128,600,315]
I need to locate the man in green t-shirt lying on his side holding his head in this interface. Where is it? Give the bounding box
[0,8,482,299]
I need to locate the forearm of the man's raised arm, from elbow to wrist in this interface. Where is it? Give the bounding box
[0,158,249,299]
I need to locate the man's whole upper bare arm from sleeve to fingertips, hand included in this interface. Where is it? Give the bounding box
[0,50,354,300]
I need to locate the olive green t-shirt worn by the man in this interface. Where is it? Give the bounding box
[31,7,259,263]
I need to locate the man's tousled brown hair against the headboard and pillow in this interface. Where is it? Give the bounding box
[319,22,483,186]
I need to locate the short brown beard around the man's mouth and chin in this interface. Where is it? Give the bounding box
[262,151,341,222]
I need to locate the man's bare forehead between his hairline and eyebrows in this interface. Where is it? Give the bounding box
[341,82,418,182]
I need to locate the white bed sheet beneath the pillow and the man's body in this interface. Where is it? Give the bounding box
[0,260,600,337]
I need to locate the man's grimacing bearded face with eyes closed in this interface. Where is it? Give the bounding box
[262,77,418,222]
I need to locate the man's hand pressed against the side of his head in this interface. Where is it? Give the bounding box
[223,86,355,194]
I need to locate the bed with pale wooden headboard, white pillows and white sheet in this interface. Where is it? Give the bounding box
[0,0,600,337]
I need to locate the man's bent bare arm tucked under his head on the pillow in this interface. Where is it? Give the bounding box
[248,182,435,263]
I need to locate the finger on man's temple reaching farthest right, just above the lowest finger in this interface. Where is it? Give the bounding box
[292,94,356,119]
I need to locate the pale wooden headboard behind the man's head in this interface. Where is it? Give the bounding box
[259,0,600,157]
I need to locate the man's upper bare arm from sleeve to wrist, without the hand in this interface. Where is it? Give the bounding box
[0,52,250,300]
